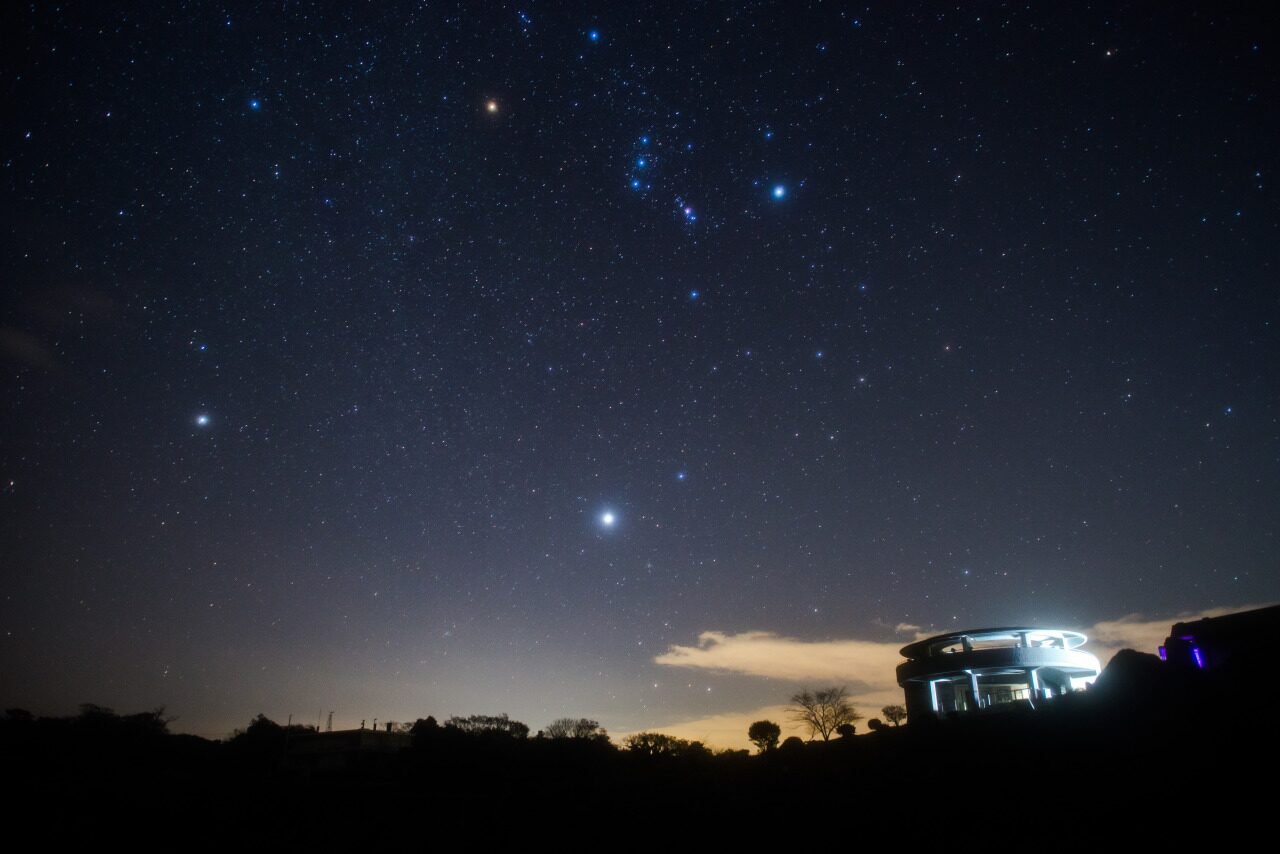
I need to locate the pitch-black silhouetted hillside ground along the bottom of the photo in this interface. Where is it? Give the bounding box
[0,653,1280,850]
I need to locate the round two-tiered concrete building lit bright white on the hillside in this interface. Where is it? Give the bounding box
[897,626,1101,721]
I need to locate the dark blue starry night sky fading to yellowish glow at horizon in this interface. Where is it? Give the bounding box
[0,0,1280,736]
